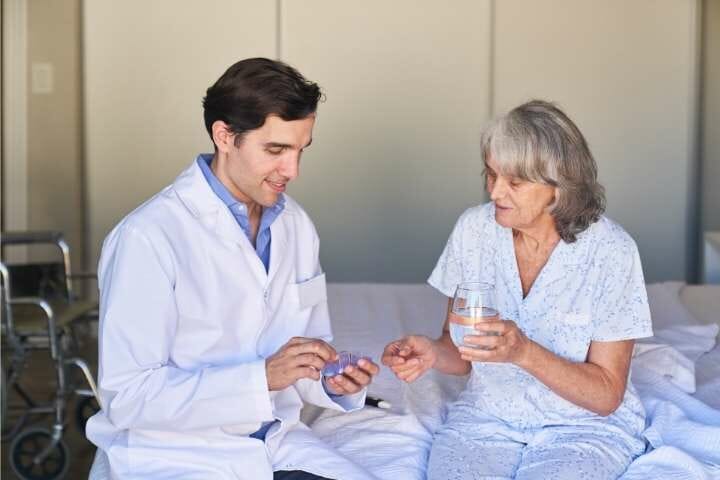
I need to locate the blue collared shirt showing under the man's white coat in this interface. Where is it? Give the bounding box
[197,153,285,272]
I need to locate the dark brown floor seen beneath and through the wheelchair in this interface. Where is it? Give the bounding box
[1,330,97,480]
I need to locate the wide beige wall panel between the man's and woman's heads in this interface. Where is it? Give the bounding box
[281,0,490,282]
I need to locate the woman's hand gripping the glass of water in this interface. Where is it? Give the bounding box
[458,320,532,365]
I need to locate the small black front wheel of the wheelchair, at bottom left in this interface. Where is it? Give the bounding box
[10,429,70,480]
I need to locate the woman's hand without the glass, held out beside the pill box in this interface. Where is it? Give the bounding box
[382,335,437,383]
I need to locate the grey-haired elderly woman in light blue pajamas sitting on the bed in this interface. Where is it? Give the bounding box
[382,101,652,480]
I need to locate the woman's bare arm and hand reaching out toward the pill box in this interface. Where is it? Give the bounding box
[382,299,470,383]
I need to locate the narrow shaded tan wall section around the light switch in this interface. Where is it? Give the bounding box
[27,0,84,268]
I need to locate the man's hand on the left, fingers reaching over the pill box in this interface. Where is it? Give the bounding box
[265,337,337,391]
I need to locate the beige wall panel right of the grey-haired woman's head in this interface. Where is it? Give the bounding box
[494,0,697,281]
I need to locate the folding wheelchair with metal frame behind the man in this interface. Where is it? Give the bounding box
[0,232,100,480]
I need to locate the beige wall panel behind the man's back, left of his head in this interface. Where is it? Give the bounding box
[84,0,276,260]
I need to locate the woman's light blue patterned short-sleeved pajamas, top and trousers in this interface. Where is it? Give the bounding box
[428,203,652,480]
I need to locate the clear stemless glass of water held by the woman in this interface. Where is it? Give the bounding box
[449,282,500,350]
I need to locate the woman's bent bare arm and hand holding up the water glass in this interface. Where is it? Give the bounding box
[460,320,635,416]
